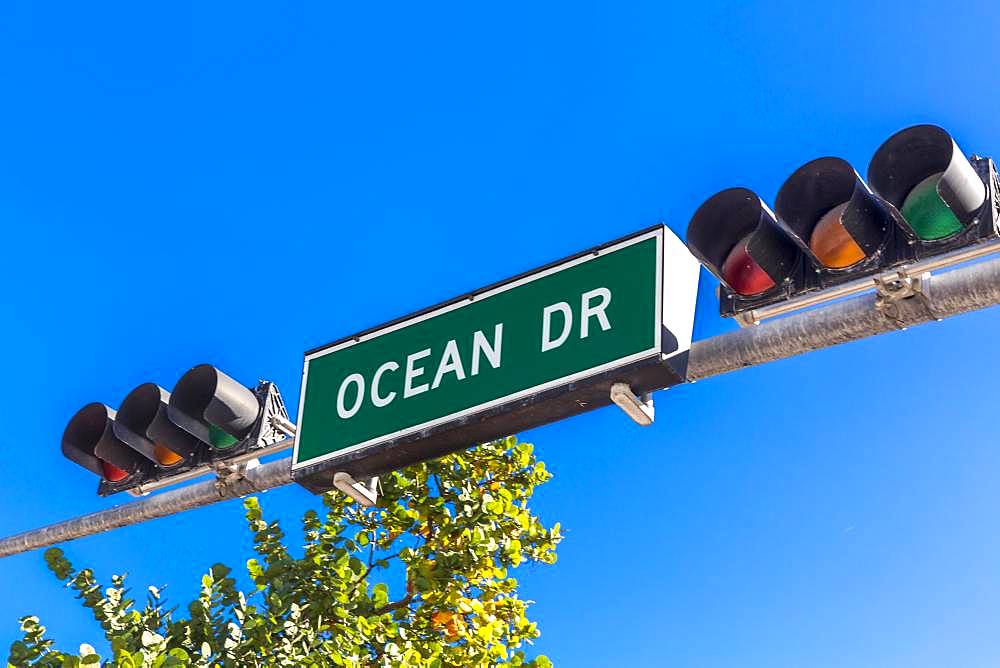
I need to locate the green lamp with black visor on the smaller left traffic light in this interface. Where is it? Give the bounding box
[167,364,261,450]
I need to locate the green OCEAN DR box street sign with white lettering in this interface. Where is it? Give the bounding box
[292,226,698,486]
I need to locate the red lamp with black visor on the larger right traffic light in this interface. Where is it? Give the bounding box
[687,188,800,296]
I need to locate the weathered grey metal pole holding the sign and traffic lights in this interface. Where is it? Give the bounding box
[0,258,1000,557]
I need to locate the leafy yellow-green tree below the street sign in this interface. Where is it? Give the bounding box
[8,437,561,668]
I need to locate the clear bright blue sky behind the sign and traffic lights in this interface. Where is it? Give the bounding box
[0,0,1000,668]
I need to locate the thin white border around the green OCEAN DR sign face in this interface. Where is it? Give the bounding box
[292,225,666,471]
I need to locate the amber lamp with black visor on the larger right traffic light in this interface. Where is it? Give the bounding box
[774,158,893,269]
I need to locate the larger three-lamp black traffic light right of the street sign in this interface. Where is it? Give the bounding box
[687,125,1000,318]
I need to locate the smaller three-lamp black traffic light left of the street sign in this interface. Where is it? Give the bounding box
[62,364,288,496]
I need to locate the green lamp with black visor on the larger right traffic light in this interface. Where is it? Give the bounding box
[868,125,986,241]
